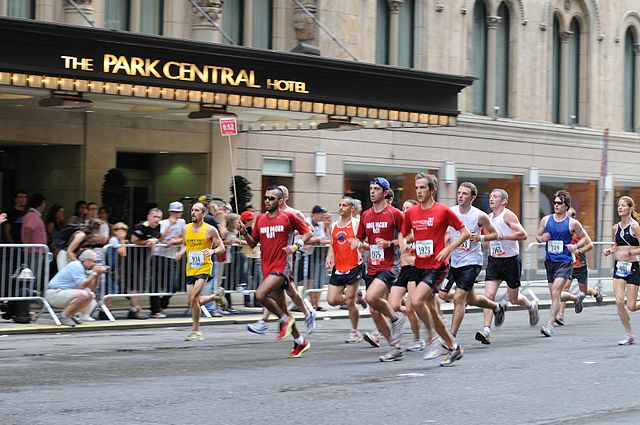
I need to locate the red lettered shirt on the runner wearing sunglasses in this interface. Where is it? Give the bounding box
[251,211,309,277]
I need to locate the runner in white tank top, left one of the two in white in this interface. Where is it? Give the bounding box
[448,182,506,337]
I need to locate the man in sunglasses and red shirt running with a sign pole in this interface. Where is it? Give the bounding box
[238,186,311,358]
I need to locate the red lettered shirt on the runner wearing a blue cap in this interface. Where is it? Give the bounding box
[356,205,402,275]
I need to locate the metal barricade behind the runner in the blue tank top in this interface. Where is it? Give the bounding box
[522,242,613,301]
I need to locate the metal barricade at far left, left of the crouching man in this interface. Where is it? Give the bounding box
[0,244,60,325]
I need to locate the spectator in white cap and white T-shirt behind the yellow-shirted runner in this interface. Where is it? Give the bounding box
[149,202,187,317]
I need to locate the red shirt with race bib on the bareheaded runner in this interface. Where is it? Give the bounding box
[402,202,464,269]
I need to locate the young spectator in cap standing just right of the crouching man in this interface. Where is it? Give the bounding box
[98,222,149,320]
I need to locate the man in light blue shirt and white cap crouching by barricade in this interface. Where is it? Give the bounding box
[46,249,108,326]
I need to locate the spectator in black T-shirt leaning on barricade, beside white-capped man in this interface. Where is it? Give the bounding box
[131,208,162,318]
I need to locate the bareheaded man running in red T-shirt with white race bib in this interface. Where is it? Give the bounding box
[398,173,469,366]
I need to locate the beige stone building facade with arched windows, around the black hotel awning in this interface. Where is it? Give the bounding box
[0,0,640,245]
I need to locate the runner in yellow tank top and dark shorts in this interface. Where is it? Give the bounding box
[176,202,224,341]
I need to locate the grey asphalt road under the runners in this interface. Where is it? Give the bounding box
[0,306,640,425]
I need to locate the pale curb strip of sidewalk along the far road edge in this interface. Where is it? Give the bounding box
[0,296,615,335]
